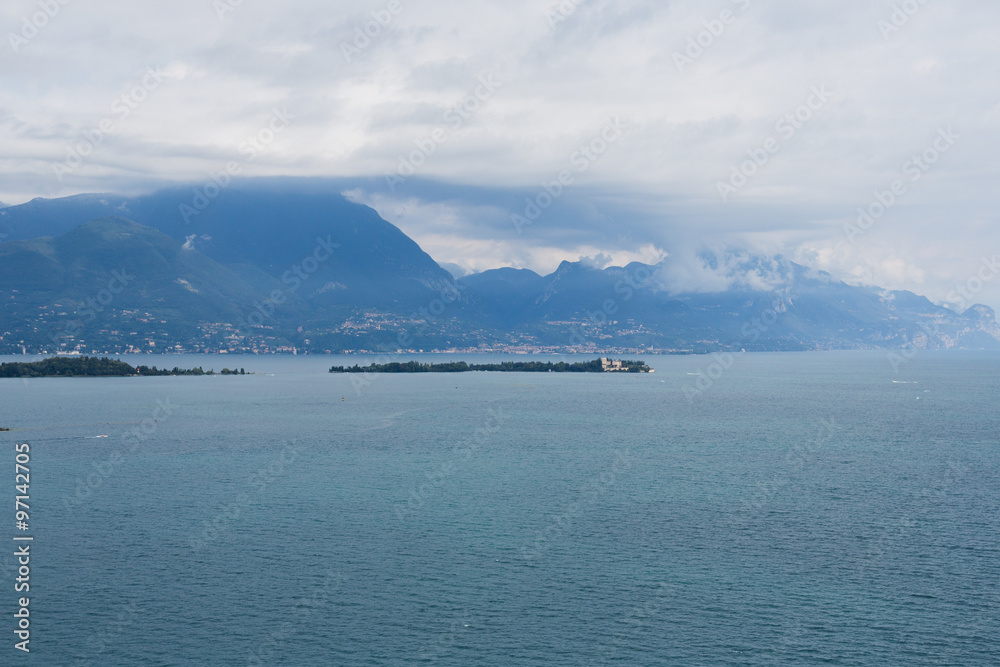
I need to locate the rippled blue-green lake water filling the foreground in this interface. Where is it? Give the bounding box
[0,352,1000,665]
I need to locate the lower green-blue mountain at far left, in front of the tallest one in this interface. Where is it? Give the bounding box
[0,218,282,351]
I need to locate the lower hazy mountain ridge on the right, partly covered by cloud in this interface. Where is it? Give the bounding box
[459,257,1000,350]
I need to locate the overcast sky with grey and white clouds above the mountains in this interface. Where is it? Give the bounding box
[0,0,1000,310]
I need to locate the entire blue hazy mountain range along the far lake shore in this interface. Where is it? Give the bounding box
[0,183,1000,353]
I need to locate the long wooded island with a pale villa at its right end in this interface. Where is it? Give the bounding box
[330,358,653,373]
